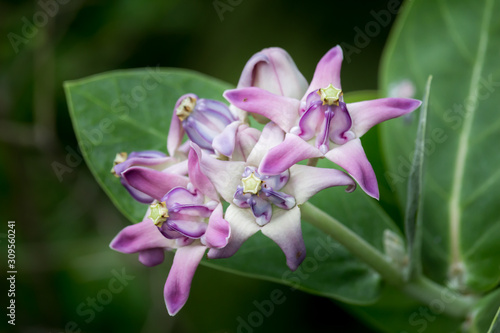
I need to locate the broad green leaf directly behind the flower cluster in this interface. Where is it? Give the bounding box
[65,69,398,304]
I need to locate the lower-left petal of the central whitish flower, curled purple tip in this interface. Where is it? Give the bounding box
[208,204,260,259]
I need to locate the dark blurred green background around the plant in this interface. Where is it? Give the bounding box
[0,0,397,333]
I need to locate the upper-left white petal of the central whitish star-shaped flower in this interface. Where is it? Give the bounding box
[200,153,245,202]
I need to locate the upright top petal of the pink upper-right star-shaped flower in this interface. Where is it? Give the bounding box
[305,45,344,96]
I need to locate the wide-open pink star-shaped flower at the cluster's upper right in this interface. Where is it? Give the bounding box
[224,46,421,199]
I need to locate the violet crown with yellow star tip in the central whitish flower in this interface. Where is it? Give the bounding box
[233,166,296,226]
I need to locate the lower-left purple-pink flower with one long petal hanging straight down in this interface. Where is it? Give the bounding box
[110,143,231,316]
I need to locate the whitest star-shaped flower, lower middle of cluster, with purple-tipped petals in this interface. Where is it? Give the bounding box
[197,123,355,270]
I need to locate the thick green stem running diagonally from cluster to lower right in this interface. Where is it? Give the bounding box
[301,202,474,318]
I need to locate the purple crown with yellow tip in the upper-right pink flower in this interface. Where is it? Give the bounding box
[291,84,355,154]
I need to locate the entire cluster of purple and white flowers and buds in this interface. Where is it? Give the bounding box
[111,46,420,315]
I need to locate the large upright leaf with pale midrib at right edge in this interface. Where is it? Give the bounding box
[381,0,500,292]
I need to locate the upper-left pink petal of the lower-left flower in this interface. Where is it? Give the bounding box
[122,167,189,200]
